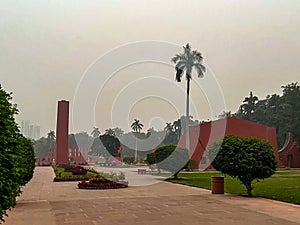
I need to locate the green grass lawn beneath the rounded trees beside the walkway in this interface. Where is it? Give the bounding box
[169,170,300,205]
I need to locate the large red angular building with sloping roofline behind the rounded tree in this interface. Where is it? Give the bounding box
[179,117,278,169]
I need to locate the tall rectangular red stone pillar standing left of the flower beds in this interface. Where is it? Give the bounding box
[55,100,69,165]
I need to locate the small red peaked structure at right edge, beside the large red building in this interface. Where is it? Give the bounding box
[278,133,300,168]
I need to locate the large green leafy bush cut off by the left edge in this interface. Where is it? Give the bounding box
[0,86,35,221]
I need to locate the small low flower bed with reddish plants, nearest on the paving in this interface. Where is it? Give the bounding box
[78,177,128,189]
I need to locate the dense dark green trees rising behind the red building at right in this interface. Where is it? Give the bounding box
[236,82,300,147]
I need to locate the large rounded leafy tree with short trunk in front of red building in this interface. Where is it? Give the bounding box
[207,136,276,196]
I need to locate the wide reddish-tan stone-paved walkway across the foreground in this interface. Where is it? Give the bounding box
[4,167,300,225]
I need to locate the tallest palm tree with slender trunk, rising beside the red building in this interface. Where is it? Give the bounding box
[172,43,205,149]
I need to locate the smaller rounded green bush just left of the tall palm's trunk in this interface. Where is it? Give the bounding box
[147,145,189,178]
